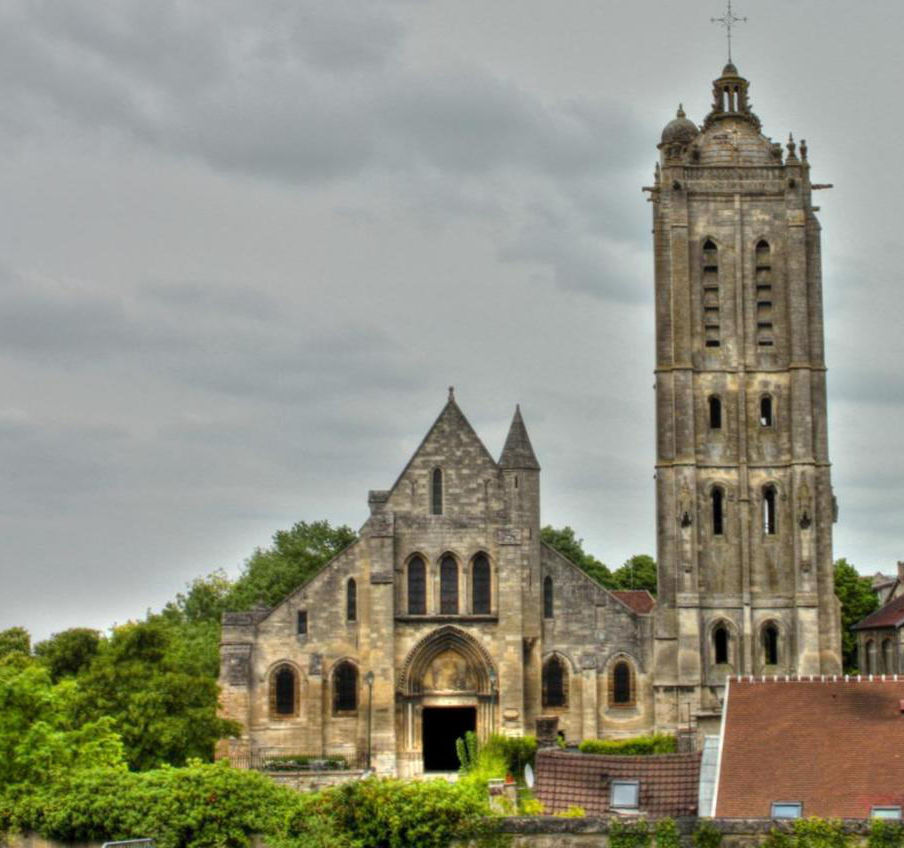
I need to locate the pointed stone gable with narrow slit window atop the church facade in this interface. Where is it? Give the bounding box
[386,388,499,514]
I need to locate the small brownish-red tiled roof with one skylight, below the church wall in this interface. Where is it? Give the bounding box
[534,749,700,816]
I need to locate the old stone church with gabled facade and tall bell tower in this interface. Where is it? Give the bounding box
[220,62,841,777]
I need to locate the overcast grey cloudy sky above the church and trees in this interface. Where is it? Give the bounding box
[0,0,904,638]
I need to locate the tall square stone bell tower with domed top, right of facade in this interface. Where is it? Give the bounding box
[649,63,841,729]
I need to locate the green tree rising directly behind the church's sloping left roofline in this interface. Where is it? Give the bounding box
[223,521,358,611]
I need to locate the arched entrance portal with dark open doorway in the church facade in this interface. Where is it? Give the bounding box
[398,626,496,776]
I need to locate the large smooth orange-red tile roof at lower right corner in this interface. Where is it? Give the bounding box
[716,676,904,818]
